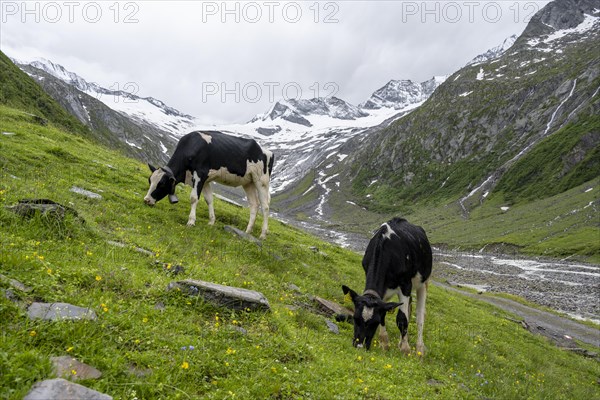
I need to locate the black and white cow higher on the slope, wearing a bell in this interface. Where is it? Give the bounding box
[144,131,274,239]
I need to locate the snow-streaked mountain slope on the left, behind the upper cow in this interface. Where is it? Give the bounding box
[11,60,191,163]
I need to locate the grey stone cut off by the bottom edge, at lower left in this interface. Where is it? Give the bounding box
[23,378,112,400]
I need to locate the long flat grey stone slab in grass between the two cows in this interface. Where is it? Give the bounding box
[167,279,271,311]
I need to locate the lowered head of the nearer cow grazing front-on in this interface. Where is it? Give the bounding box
[342,285,401,350]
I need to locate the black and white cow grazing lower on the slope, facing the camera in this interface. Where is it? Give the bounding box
[342,218,432,354]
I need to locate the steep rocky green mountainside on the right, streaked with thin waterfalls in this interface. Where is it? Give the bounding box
[340,0,600,216]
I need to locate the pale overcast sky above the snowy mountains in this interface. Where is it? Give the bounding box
[0,0,548,123]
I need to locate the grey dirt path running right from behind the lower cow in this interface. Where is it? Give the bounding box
[433,281,600,347]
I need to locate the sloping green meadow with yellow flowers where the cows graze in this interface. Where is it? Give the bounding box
[0,106,600,400]
